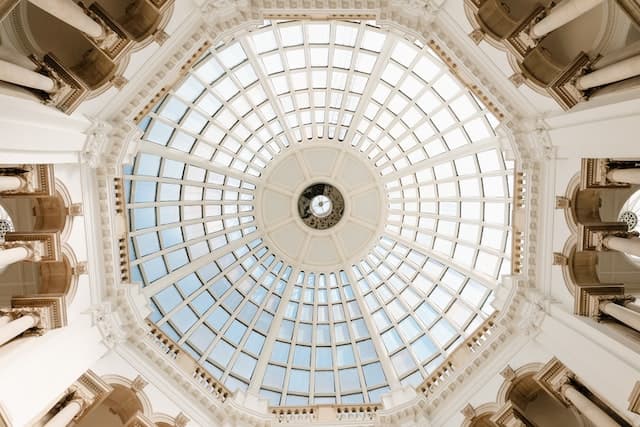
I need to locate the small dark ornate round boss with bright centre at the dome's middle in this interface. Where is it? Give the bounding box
[298,183,344,230]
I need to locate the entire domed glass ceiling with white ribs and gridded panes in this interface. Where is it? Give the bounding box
[125,21,513,405]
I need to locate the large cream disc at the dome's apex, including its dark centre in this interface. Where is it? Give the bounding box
[256,144,387,271]
